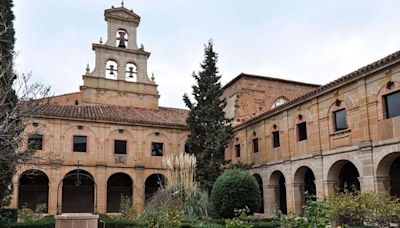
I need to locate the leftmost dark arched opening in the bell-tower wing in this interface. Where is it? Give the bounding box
[18,169,49,212]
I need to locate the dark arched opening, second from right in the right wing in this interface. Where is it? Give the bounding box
[327,159,361,195]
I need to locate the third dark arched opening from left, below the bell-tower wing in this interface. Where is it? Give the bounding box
[107,172,133,213]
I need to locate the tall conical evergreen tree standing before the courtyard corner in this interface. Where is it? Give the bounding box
[183,40,233,193]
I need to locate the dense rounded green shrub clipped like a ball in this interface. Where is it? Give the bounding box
[211,169,261,218]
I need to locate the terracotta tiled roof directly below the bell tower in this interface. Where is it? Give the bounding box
[35,104,189,127]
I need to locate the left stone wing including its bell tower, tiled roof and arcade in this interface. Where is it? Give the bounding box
[11,7,189,214]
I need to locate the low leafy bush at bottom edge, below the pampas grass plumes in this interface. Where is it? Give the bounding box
[137,207,183,228]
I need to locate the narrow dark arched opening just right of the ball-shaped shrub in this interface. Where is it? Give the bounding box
[269,170,287,214]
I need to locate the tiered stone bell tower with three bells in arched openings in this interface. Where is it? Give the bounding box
[80,5,159,109]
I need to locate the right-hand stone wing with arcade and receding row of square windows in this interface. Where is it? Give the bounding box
[225,52,400,216]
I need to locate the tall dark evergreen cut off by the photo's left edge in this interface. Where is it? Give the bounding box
[0,0,19,208]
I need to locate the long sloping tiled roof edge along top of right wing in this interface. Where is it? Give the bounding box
[235,48,400,129]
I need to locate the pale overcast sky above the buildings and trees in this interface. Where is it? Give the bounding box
[14,0,400,108]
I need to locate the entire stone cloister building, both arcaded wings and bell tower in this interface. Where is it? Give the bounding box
[11,4,400,217]
